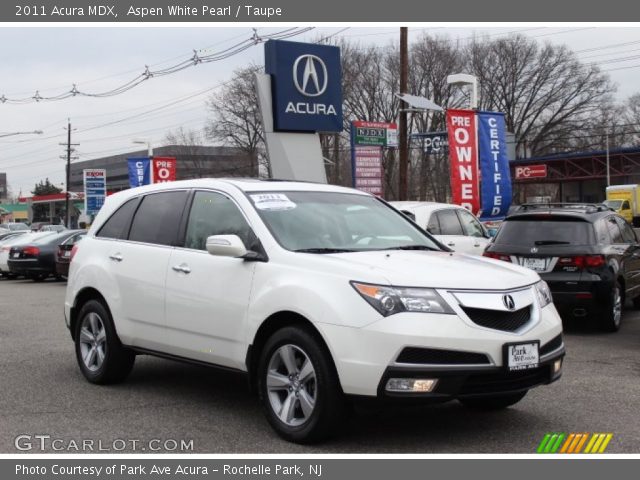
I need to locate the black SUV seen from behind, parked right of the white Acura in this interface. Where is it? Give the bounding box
[484,204,640,332]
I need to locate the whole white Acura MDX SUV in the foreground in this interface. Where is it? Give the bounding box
[65,179,564,442]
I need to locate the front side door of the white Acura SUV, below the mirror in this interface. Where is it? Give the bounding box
[166,190,258,368]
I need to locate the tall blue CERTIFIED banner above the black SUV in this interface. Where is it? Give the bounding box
[478,112,511,220]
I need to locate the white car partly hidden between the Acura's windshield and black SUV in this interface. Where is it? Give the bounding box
[391,202,491,255]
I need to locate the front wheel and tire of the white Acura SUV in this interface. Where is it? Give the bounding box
[257,326,346,443]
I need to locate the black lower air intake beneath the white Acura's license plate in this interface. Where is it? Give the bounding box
[459,366,551,395]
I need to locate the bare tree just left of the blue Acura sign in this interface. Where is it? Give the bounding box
[206,65,268,171]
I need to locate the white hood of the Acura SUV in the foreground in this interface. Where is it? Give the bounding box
[323,250,540,290]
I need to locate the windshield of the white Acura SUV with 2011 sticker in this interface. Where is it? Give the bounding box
[249,192,440,253]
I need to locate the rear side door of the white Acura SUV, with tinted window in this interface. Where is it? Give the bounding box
[101,190,188,350]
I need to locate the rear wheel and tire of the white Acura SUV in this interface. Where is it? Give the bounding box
[75,300,136,385]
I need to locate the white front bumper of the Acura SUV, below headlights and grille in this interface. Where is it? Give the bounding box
[317,304,564,397]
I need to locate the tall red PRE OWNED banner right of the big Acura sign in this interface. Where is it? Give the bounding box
[447,110,480,213]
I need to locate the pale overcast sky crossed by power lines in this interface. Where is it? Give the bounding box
[0,26,640,194]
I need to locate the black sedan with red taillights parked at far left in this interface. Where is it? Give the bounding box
[7,230,84,282]
